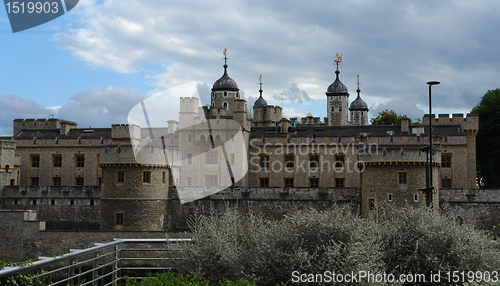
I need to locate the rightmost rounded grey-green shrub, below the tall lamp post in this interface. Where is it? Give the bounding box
[382,207,500,282]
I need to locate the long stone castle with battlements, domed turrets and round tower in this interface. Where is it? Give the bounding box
[0,52,500,260]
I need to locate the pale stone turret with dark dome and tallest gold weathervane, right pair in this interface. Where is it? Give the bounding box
[326,57,349,126]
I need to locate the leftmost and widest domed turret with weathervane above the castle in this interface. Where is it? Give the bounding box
[211,50,240,112]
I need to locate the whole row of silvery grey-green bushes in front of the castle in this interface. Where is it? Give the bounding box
[178,203,500,285]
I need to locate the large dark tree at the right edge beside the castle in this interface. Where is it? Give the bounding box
[471,88,500,188]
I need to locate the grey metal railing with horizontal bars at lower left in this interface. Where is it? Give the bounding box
[0,238,193,286]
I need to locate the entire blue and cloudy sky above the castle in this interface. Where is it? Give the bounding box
[0,0,500,135]
